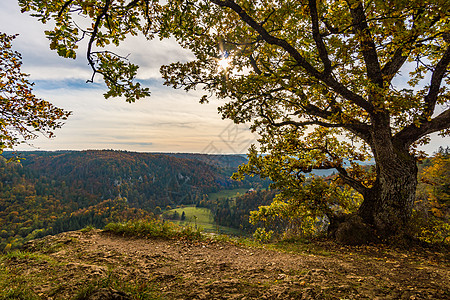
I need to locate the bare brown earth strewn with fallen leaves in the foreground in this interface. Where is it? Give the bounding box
[6,230,450,299]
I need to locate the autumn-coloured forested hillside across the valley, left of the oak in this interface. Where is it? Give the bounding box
[0,150,260,249]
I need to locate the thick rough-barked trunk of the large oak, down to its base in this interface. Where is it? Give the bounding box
[329,118,418,244]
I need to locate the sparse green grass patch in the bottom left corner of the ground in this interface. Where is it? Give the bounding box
[0,247,160,300]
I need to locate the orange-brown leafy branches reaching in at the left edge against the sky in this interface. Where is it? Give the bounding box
[0,32,70,153]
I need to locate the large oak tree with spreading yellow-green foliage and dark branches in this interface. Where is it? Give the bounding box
[19,0,450,241]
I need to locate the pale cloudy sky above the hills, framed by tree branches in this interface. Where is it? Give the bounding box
[0,0,450,154]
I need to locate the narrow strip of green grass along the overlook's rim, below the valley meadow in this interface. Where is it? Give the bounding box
[105,220,203,240]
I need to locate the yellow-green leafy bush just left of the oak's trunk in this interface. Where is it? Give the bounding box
[249,177,361,239]
